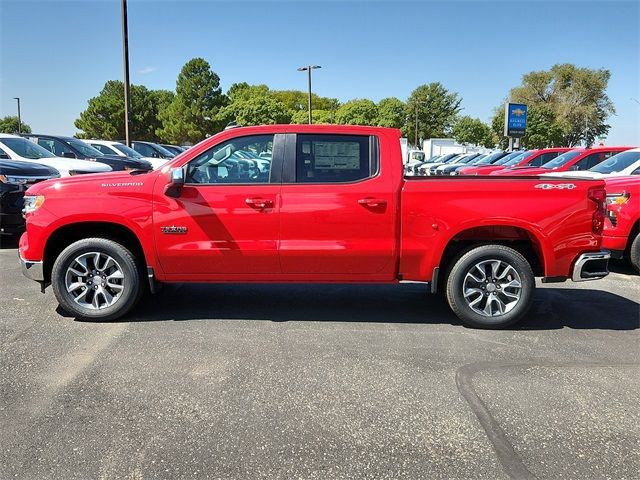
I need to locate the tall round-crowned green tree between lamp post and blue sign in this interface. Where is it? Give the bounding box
[403,82,462,143]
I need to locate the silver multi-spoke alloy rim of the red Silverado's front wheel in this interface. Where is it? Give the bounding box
[65,252,125,310]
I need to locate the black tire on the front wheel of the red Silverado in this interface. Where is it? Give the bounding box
[51,238,144,321]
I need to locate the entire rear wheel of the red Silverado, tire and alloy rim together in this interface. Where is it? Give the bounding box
[446,245,536,329]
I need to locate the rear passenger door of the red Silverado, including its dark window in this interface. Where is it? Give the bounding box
[279,134,396,280]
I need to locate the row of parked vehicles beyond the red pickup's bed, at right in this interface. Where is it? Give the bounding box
[405,146,640,272]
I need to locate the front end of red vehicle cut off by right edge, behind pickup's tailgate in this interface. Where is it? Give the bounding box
[602,176,640,273]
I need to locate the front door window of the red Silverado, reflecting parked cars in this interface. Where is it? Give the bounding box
[187,135,273,184]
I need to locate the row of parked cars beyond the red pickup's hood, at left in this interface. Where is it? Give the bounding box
[0,133,186,234]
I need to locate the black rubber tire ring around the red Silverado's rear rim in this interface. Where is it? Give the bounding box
[447,245,535,329]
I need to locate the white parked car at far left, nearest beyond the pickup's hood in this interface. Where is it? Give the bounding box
[0,133,111,177]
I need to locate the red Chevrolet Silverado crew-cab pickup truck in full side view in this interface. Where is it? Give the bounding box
[19,125,609,328]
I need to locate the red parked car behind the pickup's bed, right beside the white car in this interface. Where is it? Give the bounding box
[489,147,633,175]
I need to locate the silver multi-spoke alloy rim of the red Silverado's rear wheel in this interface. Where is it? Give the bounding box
[462,259,522,317]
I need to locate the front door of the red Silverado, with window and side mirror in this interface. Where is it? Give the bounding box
[153,134,283,280]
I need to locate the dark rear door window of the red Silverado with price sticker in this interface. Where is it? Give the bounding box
[296,135,372,183]
